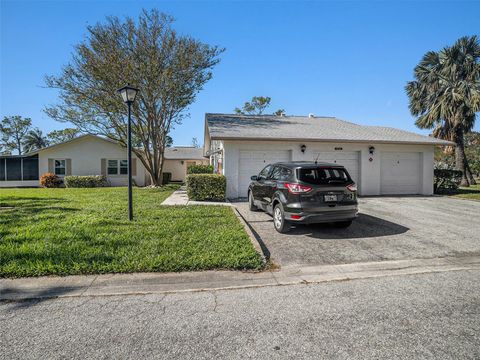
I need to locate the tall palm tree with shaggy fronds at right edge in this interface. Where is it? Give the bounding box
[406,36,480,186]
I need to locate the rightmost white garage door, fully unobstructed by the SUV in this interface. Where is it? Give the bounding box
[380,152,421,195]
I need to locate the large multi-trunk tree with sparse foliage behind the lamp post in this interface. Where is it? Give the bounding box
[45,10,224,185]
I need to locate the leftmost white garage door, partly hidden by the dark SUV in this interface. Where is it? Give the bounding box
[238,150,292,197]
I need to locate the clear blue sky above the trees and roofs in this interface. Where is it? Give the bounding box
[0,0,480,145]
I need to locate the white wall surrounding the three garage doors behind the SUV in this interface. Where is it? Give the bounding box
[223,141,434,198]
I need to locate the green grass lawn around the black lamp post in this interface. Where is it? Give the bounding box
[0,186,262,277]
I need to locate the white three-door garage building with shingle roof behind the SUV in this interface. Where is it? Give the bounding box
[204,114,452,198]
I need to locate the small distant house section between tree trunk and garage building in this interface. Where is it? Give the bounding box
[163,146,209,182]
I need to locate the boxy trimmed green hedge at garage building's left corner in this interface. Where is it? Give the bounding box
[187,174,227,201]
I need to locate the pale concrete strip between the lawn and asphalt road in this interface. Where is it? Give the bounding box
[0,256,480,301]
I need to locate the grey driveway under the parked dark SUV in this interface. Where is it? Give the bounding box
[236,197,480,266]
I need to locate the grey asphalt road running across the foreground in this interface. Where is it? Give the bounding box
[0,270,480,359]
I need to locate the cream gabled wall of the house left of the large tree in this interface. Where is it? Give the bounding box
[37,136,145,186]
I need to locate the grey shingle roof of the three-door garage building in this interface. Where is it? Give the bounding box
[205,114,452,145]
